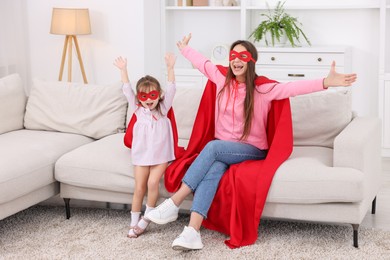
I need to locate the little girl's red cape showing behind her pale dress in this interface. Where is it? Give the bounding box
[123,108,184,159]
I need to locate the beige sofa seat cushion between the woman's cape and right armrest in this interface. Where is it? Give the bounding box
[267,146,369,204]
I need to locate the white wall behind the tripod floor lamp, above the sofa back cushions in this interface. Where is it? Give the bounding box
[25,0,159,88]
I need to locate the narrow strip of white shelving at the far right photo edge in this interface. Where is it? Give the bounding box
[378,0,390,157]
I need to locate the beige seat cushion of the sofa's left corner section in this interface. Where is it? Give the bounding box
[0,129,93,204]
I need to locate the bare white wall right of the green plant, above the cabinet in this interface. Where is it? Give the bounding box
[284,8,379,115]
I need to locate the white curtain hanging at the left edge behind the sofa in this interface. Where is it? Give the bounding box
[0,0,29,89]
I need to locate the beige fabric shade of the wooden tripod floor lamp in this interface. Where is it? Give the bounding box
[50,8,91,35]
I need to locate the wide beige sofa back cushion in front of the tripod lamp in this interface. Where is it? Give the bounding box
[24,79,127,139]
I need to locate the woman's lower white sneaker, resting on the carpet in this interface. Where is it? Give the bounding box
[172,226,203,250]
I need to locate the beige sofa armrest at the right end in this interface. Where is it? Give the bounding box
[333,117,382,175]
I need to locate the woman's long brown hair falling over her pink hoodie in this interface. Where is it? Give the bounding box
[218,40,258,140]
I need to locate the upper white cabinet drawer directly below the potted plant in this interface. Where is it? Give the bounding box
[257,52,344,66]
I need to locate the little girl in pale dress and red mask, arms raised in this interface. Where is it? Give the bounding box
[114,53,176,238]
